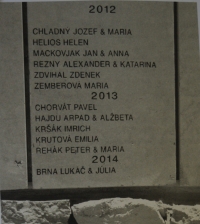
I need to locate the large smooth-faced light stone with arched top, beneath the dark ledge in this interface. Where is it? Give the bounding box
[72,198,165,224]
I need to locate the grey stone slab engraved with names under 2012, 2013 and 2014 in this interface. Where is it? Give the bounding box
[28,2,176,189]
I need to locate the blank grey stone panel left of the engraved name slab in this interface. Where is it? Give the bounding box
[0,3,27,190]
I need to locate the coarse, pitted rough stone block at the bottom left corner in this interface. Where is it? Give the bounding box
[1,200,71,224]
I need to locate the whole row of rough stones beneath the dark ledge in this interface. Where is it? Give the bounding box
[2,198,200,224]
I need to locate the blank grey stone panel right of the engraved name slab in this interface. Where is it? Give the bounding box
[178,3,200,186]
